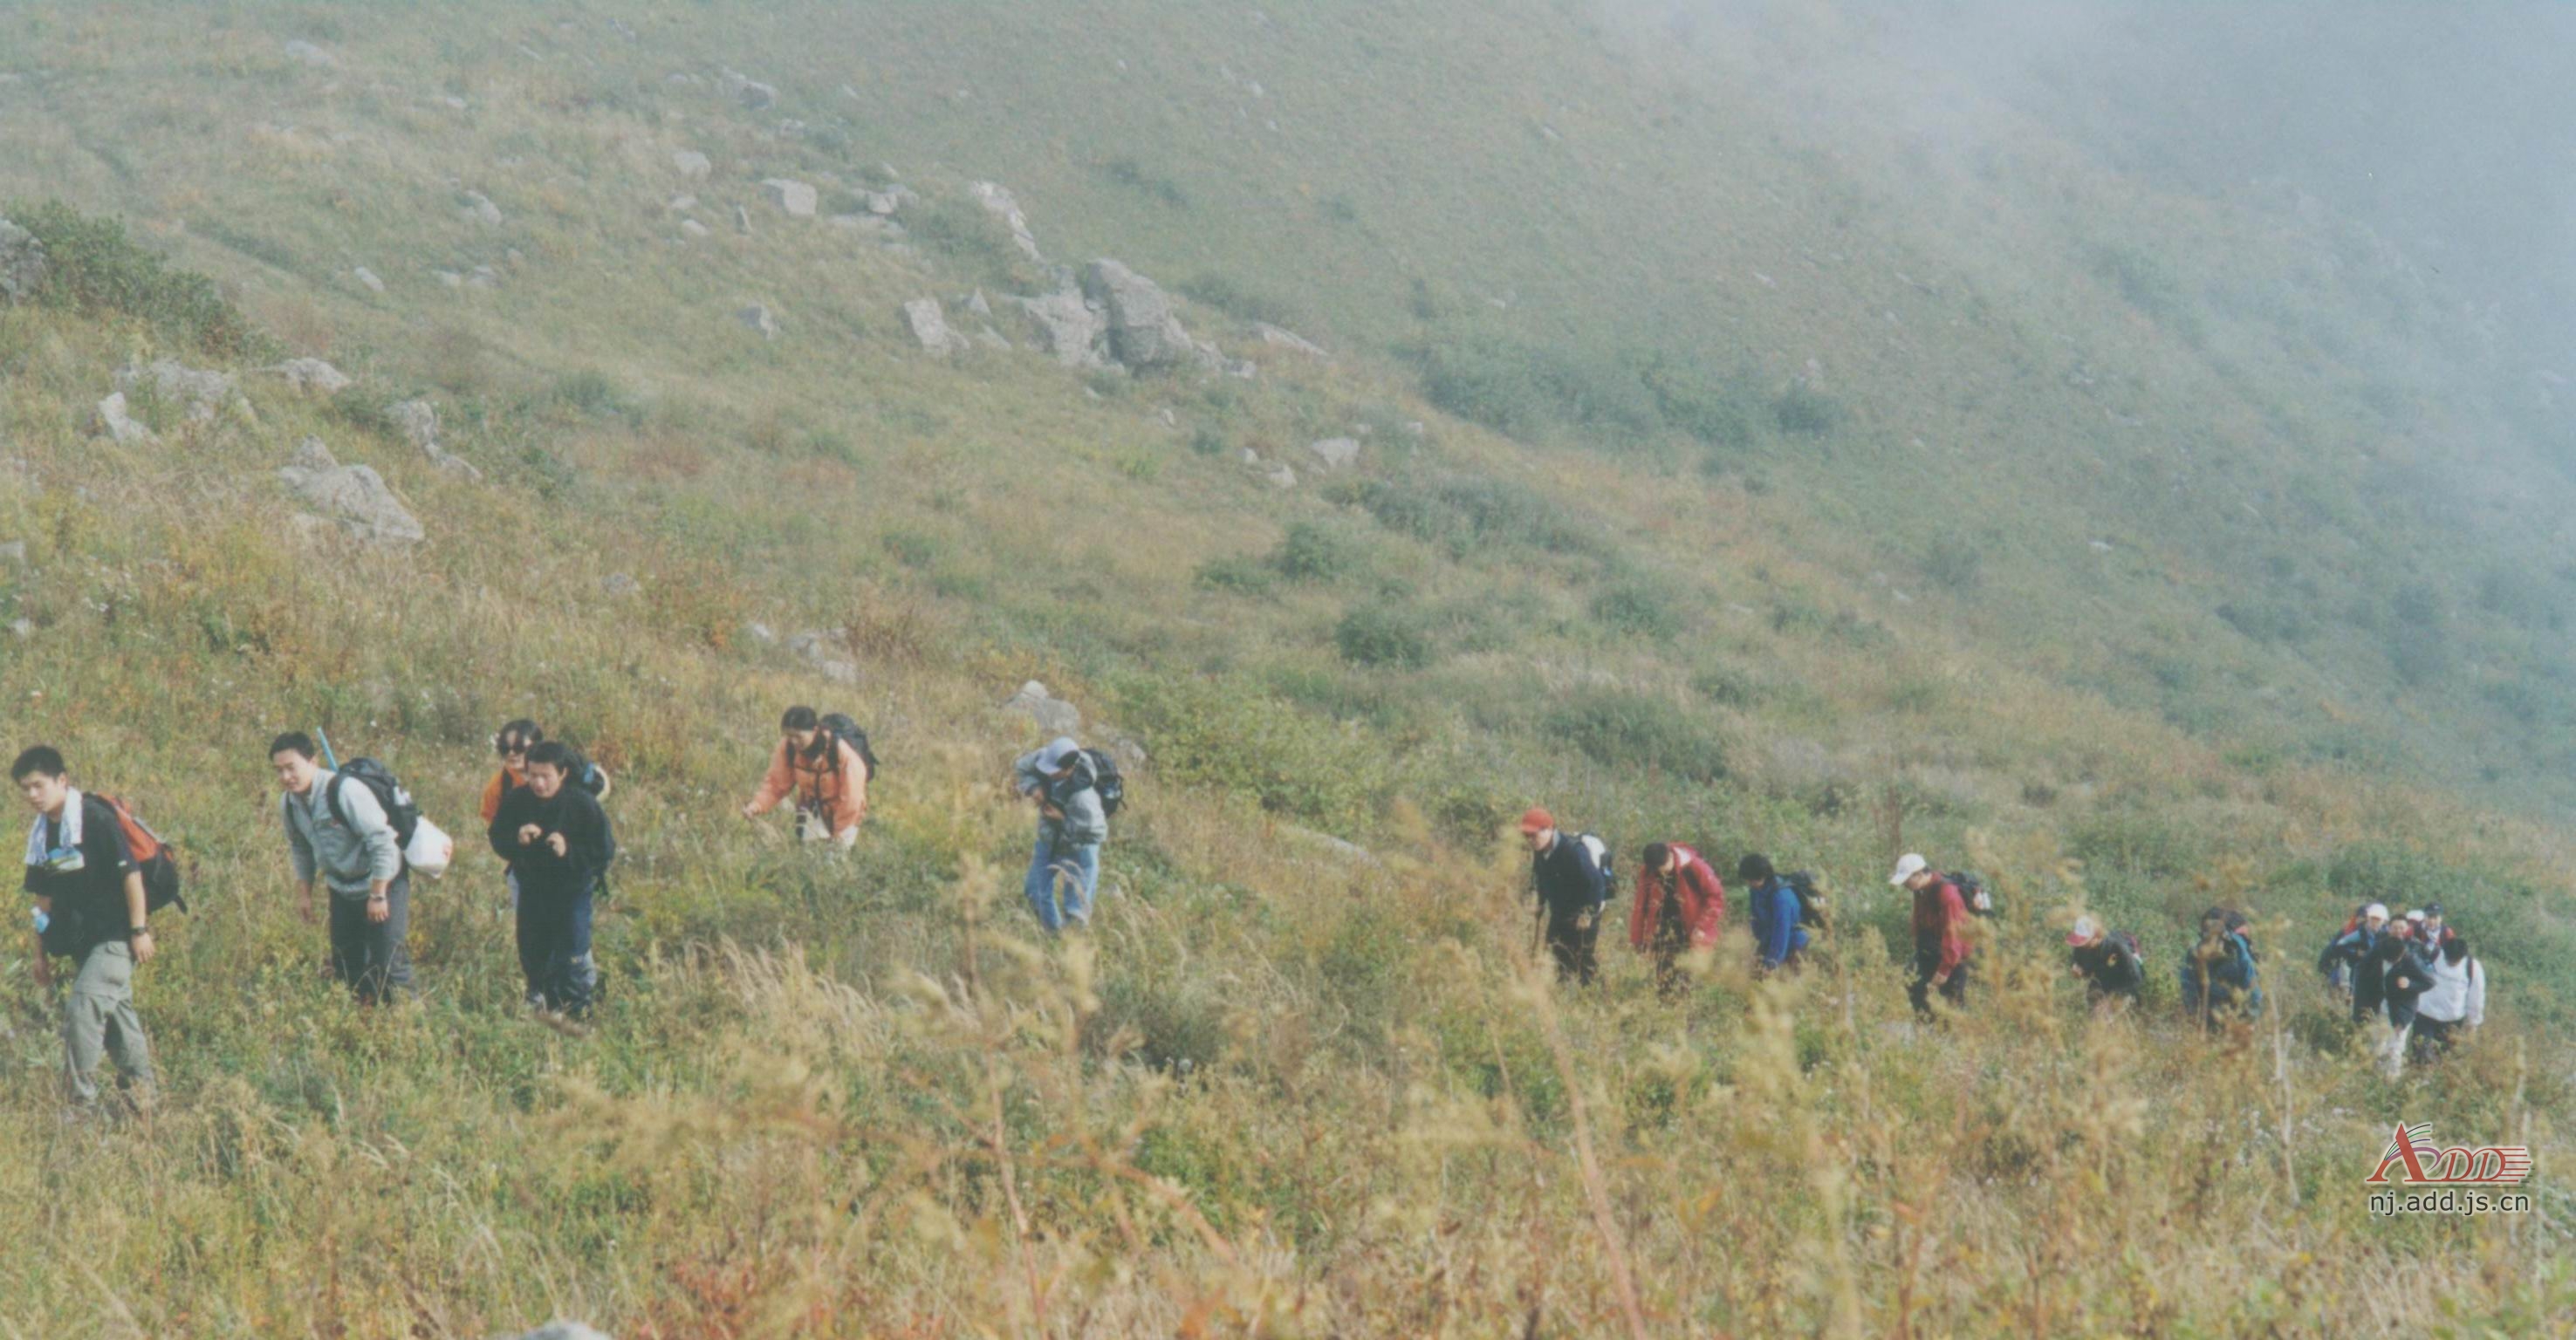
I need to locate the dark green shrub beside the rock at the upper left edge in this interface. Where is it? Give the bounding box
[8,201,273,359]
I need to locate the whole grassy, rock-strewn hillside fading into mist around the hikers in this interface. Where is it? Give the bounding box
[0,0,2576,1337]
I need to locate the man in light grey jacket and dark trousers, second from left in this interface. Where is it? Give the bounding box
[268,732,412,1005]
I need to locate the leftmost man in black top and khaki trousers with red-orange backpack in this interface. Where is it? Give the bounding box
[8,745,152,1111]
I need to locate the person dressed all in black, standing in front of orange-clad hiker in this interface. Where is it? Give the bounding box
[487,740,618,1021]
